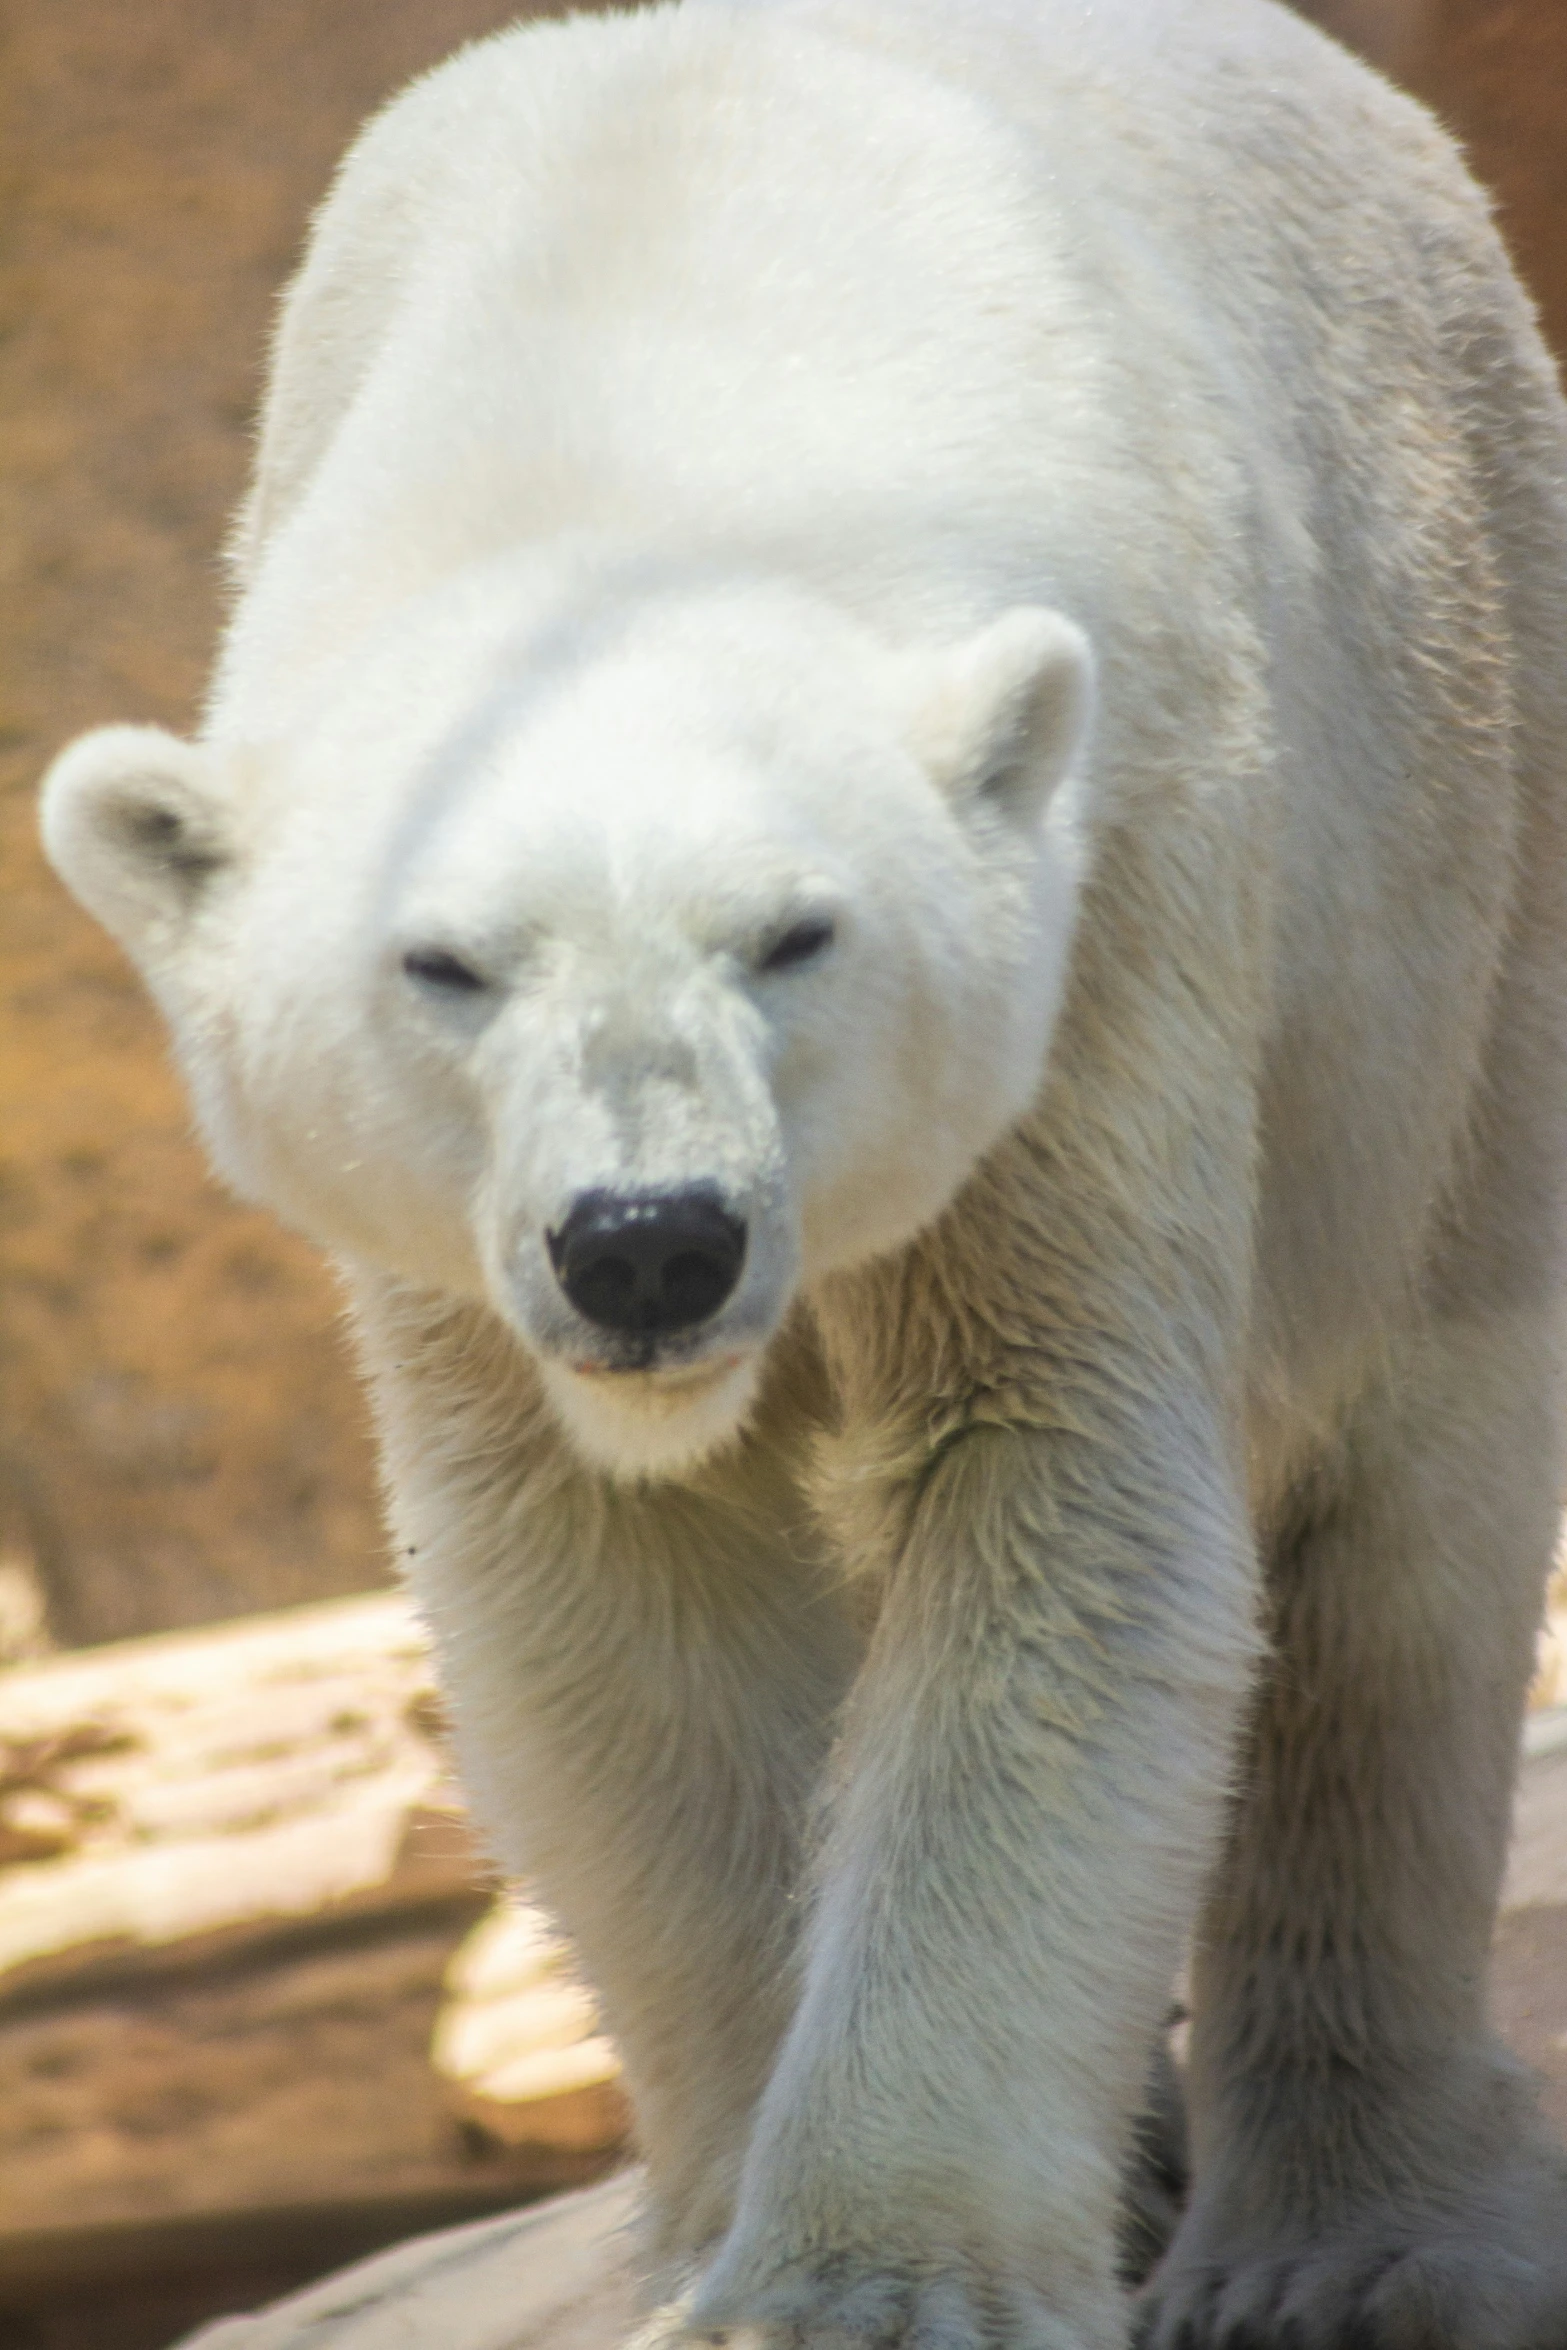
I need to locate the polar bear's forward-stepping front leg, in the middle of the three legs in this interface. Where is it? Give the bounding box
[684,1238,1255,2350]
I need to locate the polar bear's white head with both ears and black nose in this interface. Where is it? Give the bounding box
[45,571,1090,1476]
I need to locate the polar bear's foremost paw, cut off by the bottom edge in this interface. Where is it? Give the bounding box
[627,2256,1085,2350]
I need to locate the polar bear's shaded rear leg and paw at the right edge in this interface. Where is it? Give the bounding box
[1146,1297,1567,2350]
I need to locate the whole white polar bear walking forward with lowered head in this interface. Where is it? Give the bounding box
[45,0,1567,2350]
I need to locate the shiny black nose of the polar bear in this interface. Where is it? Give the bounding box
[550,1184,745,1335]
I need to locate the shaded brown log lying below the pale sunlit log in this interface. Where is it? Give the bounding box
[0,1918,604,2256]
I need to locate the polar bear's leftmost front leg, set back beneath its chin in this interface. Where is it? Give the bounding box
[357,1278,862,2280]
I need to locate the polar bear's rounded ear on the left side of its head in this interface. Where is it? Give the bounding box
[42,726,233,954]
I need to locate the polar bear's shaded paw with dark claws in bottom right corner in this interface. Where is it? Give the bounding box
[1135,2164,1567,2350]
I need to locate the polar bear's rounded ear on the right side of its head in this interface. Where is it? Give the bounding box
[909,604,1095,825]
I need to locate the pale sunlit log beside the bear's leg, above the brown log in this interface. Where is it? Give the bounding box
[0,1593,482,2005]
